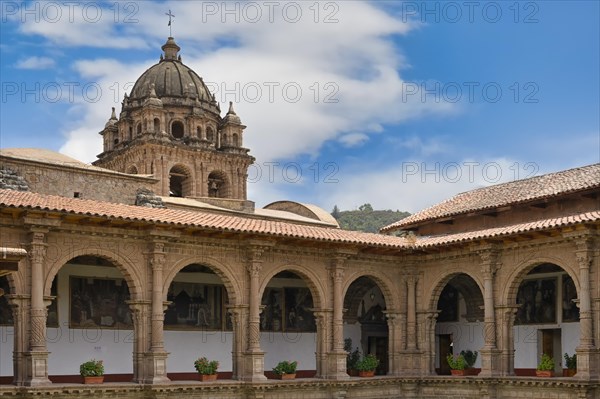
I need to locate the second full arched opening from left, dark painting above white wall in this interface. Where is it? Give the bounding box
[164,263,233,380]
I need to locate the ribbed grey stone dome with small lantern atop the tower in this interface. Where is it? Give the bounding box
[129,37,220,113]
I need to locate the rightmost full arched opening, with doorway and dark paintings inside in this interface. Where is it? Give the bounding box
[512,263,580,376]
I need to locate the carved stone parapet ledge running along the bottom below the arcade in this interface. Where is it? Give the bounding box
[0,377,600,399]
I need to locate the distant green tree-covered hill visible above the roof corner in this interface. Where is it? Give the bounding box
[331,204,410,233]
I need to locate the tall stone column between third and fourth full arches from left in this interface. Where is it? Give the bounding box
[323,255,349,380]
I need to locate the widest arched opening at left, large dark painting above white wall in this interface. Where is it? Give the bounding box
[46,255,134,382]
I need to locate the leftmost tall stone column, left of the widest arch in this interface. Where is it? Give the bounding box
[25,228,51,386]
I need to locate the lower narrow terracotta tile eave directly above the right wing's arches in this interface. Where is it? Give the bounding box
[415,211,600,249]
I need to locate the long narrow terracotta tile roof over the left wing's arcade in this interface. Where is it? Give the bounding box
[0,190,410,248]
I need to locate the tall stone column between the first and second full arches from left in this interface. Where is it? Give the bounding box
[143,241,170,384]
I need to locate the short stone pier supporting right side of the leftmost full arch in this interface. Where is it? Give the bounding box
[126,300,152,383]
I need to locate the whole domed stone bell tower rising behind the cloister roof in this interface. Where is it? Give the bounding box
[94,37,254,209]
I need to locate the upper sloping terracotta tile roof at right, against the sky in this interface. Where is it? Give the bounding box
[381,163,600,232]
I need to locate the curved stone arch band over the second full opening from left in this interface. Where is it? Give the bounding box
[163,256,242,305]
